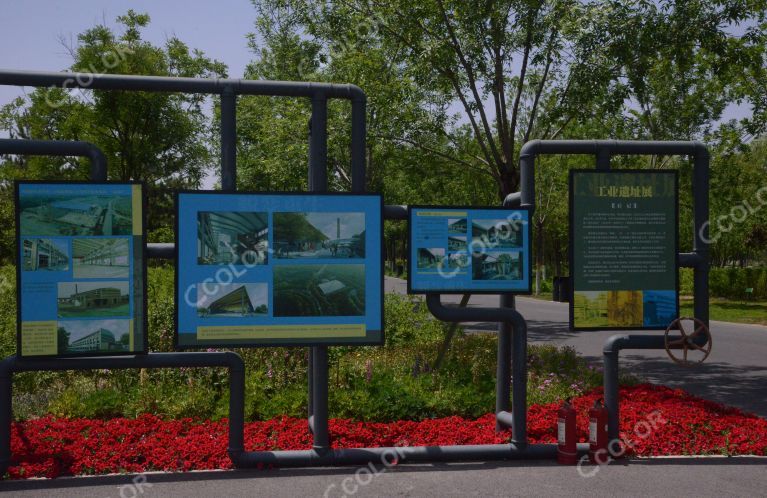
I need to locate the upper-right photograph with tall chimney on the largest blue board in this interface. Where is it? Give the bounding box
[273,212,365,259]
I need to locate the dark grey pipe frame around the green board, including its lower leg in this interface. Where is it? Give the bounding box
[506,140,710,439]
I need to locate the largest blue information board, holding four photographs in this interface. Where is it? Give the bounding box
[176,191,383,348]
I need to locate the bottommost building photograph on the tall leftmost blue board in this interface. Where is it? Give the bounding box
[58,320,131,354]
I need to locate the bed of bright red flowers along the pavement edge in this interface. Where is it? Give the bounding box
[8,384,767,478]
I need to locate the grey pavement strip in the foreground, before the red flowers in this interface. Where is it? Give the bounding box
[0,458,767,498]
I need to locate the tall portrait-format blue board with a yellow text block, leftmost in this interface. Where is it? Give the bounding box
[15,181,147,357]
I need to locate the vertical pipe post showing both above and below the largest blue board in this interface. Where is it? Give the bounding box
[308,94,330,451]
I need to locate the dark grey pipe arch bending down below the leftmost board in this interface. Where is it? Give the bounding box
[0,351,245,475]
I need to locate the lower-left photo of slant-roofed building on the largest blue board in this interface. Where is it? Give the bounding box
[197,282,269,317]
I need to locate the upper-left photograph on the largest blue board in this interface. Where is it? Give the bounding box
[197,211,269,265]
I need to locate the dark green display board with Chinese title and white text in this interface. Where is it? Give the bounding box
[570,170,679,330]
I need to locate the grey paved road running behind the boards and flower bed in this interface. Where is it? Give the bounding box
[386,277,767,417]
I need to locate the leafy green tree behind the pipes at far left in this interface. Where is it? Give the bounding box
[0,10,226,228]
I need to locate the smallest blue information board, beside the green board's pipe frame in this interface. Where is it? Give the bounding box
[408,206,531,294]
